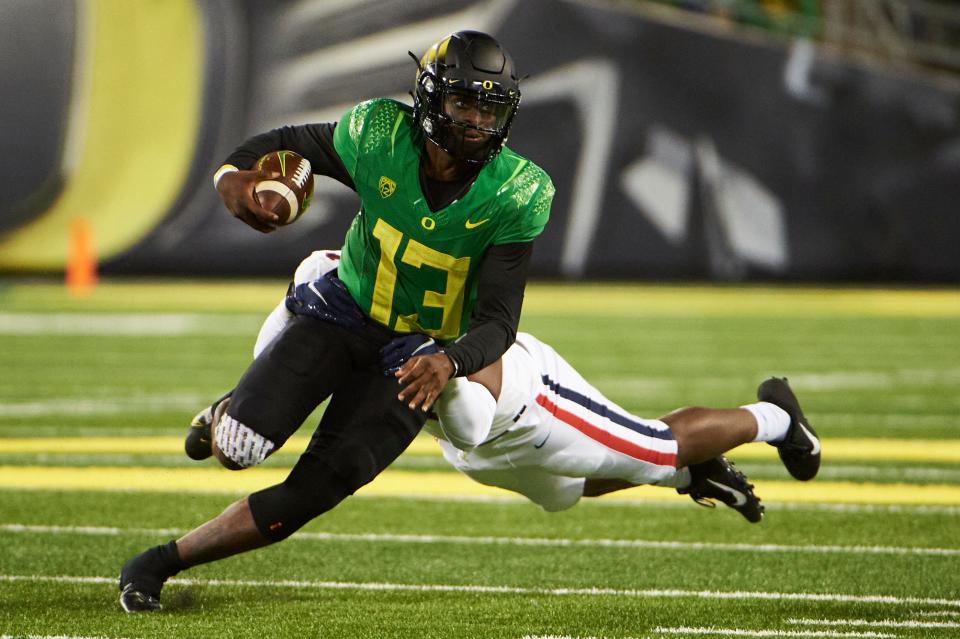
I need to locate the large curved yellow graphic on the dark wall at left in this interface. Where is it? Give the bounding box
[0,0,204,271]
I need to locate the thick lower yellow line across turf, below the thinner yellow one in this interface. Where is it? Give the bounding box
[0,466,960,505]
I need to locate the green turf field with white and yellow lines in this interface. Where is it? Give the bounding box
[0,281,960,639]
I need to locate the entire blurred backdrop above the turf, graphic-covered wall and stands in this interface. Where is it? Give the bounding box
[0,0,960,283]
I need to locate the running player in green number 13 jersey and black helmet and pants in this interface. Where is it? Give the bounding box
[119,31,554,612]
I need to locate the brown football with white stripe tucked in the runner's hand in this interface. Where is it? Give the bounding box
[254,151,313,224]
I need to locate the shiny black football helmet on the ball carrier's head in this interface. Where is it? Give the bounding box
[411,31,520,164]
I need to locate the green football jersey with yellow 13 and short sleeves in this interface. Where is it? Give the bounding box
[334,99,554,341]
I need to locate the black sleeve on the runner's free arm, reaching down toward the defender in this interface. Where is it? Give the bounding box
[444,242,533,377]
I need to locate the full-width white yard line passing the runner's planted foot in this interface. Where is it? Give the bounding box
[0,575,960,608]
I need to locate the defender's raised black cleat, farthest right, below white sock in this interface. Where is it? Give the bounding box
[757,377,820,481]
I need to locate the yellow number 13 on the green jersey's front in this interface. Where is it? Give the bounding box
[370,218,470,339]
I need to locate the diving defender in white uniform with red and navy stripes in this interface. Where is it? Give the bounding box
[193,251,820,522]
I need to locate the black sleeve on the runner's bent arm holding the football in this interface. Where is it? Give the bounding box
[223,122,357,191]
